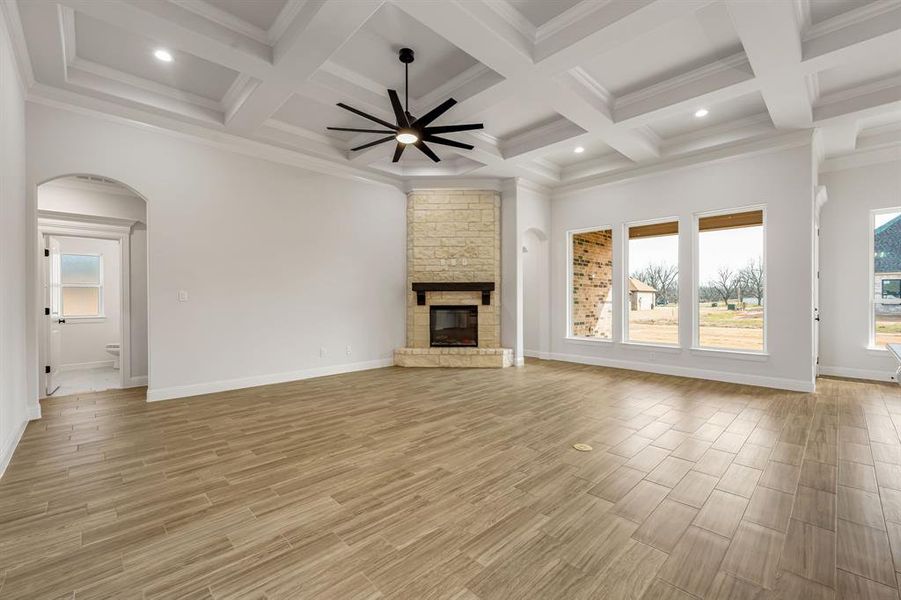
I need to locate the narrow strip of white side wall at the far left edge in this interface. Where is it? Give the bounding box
[0,8,31,475]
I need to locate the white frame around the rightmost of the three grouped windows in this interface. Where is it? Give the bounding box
[680,204,770,357]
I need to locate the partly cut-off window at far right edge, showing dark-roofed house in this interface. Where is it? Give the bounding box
[870,208,901,348]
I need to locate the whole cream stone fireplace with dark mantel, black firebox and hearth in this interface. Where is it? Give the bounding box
[394,190,513,367]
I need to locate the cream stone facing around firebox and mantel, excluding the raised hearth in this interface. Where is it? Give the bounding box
[407,190,501,348]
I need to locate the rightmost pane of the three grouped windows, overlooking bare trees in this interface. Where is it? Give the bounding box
[697,209,766,352]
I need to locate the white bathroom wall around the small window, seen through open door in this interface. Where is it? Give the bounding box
[54,236,122,369]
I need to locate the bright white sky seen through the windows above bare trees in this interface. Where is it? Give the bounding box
[629,226,764,284]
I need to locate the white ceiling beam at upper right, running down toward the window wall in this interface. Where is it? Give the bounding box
[726,0,813,129]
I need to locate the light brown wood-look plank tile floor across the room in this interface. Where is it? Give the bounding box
[0,361,901,600]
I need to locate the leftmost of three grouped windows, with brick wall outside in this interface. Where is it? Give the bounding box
[572,229,613,339]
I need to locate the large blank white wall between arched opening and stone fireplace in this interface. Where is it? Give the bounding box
[28,105,406,406]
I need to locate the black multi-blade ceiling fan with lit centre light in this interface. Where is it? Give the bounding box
[326,48,484,162]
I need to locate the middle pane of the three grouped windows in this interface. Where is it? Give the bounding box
[625,221,679,345]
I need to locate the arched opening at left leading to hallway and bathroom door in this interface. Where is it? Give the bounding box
[37,175,148,397]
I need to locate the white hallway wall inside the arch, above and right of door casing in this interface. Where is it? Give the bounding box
[37,177,147,385]
